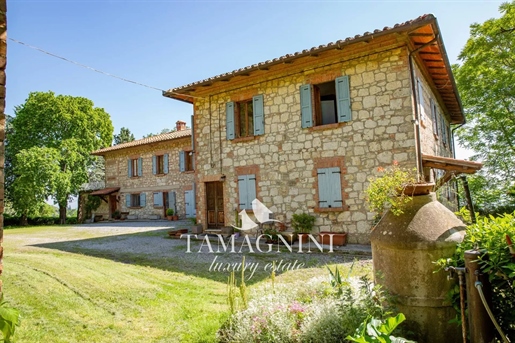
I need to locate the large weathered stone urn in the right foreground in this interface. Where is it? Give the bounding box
[370,193,465,343]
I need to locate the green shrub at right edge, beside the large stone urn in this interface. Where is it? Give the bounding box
[437,213,515,337]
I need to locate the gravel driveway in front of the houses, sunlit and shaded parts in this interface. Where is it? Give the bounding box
[31,220,371,279]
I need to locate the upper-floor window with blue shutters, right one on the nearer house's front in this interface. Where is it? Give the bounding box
[300,76,352,128]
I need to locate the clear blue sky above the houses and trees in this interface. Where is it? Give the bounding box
[6,0,501,149]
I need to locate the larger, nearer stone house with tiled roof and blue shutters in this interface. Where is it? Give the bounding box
[163,15,464,243]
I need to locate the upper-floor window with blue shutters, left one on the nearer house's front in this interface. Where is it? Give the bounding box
[225,95,265,140]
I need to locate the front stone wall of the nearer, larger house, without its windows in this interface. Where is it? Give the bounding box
[194,39,416,243]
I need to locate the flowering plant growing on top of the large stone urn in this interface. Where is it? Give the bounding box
[365,161,416,216]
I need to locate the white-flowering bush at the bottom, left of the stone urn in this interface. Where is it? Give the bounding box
[218,277,402,343]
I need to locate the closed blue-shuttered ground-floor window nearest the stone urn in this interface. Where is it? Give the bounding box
[317,167,343,208]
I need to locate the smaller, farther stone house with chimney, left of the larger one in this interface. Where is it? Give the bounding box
[90,121,196,219]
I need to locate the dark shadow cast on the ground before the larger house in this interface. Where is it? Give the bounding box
[33,225,370,285]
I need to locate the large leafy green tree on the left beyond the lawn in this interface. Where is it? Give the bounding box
[8,92,113,224]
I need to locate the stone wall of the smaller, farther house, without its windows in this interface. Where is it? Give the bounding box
[105,137,194,219]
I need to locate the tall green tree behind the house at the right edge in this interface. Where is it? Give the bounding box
[453,1,515,214]
